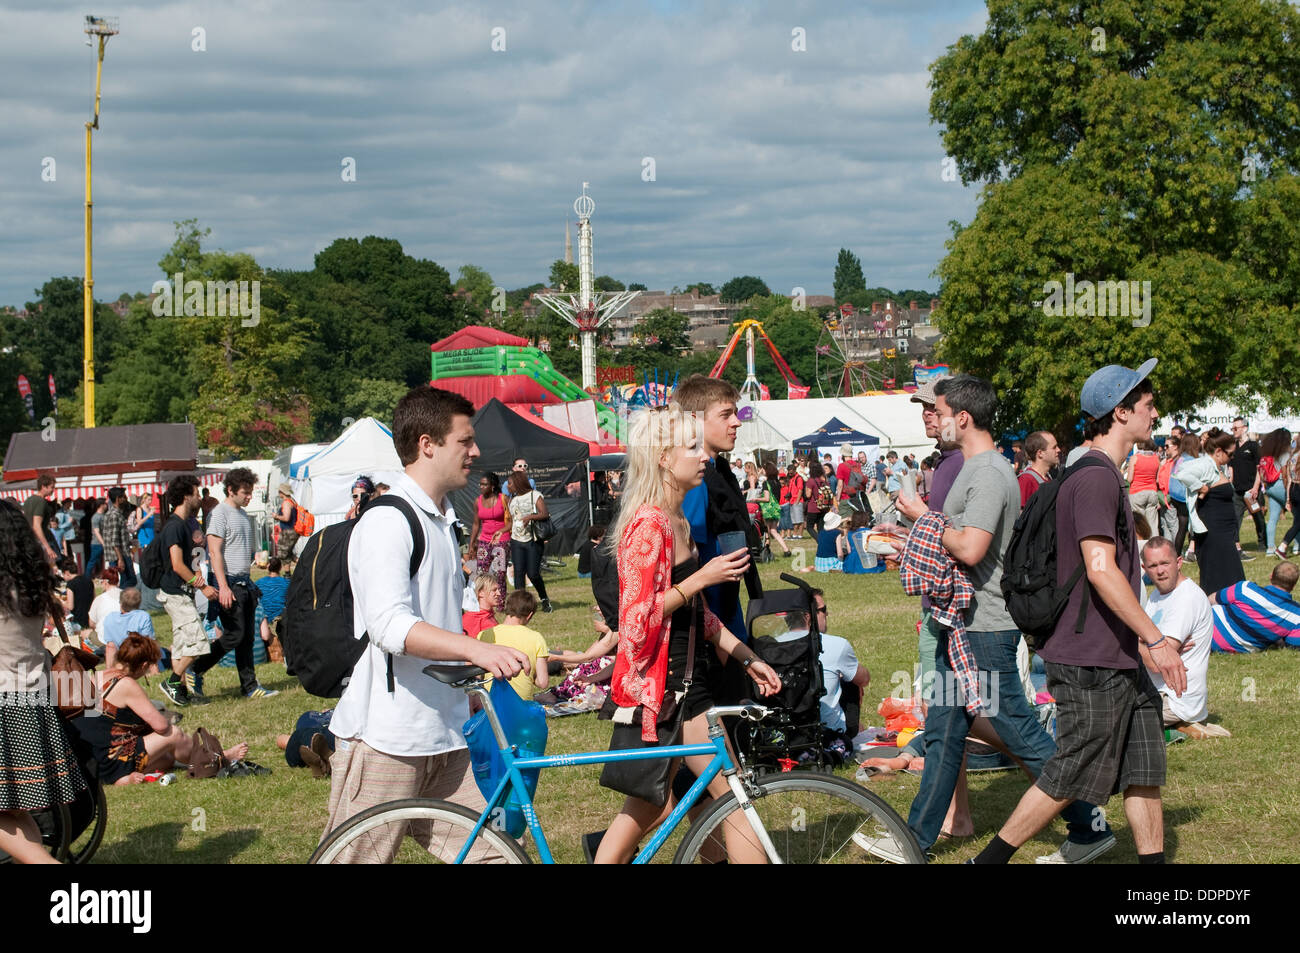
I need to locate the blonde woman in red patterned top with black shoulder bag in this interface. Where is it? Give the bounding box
[595,403,781,863]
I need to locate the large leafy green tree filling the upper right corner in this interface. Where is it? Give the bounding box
[931,0,1300,436]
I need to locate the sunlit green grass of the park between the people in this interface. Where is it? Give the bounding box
[95,524,1300,863]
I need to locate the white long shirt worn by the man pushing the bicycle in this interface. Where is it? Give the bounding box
[330,473,469,757]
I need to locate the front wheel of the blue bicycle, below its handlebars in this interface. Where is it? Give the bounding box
[672,772,926,863]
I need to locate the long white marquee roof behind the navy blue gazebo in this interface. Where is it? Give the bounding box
[733,394,935,456]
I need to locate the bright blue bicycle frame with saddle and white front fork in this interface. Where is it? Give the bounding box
[454,683,781,863]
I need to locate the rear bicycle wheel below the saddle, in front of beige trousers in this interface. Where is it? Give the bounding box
[311,797,529,863]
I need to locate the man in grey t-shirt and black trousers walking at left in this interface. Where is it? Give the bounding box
[186,467,280,698]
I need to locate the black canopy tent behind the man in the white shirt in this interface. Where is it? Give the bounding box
[451,398,592,554]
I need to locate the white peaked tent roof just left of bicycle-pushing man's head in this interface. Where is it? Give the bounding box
[294,417,402,520]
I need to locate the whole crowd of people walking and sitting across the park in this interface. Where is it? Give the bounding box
[0,360,1300,863]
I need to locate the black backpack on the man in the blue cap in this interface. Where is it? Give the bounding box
[1002,454,1128,649]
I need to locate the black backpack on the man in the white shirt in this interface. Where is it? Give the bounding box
[276,493,424,698]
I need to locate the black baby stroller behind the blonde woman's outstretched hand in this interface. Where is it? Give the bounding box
[735,572,835,771]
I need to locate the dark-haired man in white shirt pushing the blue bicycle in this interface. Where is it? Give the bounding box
[325,386,527,862]
